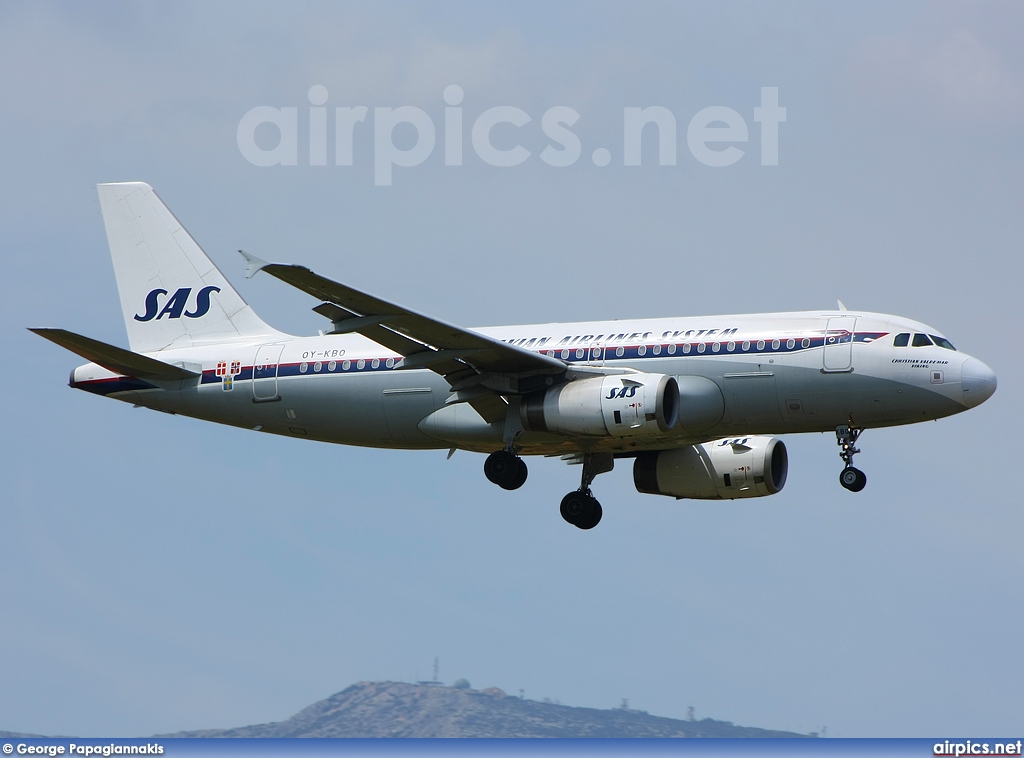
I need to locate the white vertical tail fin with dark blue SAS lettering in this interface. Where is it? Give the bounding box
[97,181,280,352]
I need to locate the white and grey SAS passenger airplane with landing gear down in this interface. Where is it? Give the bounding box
[31,182,996,530]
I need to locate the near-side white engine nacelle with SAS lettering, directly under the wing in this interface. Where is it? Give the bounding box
[520,374,679,437]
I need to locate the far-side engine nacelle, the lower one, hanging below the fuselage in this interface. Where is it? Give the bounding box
[633,436,790,500]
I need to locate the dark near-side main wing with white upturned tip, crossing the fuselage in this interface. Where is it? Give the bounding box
[239,250,566,422]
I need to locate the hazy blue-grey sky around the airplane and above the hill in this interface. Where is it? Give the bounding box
[0,2,1024,736]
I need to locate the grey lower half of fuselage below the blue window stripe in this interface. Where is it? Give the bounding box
[101,357,965,455]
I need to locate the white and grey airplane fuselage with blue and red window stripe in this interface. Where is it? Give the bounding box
[72,311,987,454]
